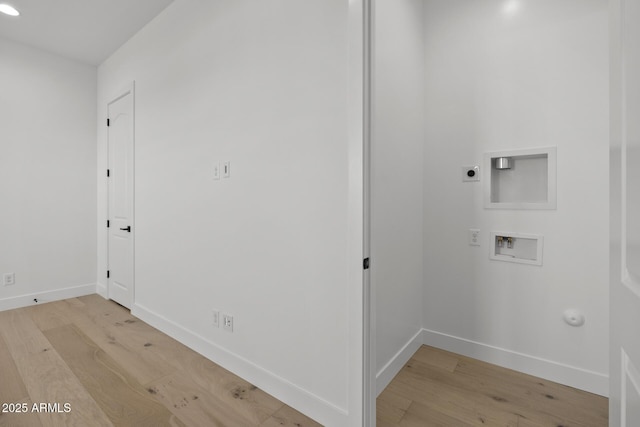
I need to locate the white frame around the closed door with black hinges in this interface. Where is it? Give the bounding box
[105,81,136,309]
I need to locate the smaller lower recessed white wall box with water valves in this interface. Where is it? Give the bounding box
[489,231,544,265]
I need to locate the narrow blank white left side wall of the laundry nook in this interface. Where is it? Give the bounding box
[371,0,424,392]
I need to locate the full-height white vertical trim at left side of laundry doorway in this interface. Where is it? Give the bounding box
[348,0,368,427]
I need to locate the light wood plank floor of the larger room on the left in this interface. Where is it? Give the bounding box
[0,295,319,427]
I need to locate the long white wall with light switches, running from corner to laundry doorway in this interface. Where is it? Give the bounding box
[98,0,354,425]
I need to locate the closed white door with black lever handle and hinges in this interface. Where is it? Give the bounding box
[107,85,134,308]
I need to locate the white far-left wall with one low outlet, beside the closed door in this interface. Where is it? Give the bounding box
[0,39,96,310]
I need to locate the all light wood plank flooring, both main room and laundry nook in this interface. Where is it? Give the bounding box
[0,295,608,427]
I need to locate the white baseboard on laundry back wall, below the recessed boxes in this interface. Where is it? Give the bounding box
[422,329,609,397]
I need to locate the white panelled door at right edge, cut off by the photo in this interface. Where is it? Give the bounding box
[609,0,640,427]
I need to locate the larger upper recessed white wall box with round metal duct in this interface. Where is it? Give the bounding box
[484,147,556,209]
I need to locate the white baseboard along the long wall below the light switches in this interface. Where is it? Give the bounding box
[131,304,348,426]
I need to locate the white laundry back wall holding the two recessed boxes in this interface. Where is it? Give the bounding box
[424,0,609,394]
